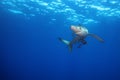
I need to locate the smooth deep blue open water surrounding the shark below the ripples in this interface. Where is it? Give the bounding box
[0,6,120,80]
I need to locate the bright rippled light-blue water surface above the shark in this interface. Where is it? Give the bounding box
[0,0,120,24]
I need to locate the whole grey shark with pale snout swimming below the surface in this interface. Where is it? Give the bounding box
[58,25,104,52]
